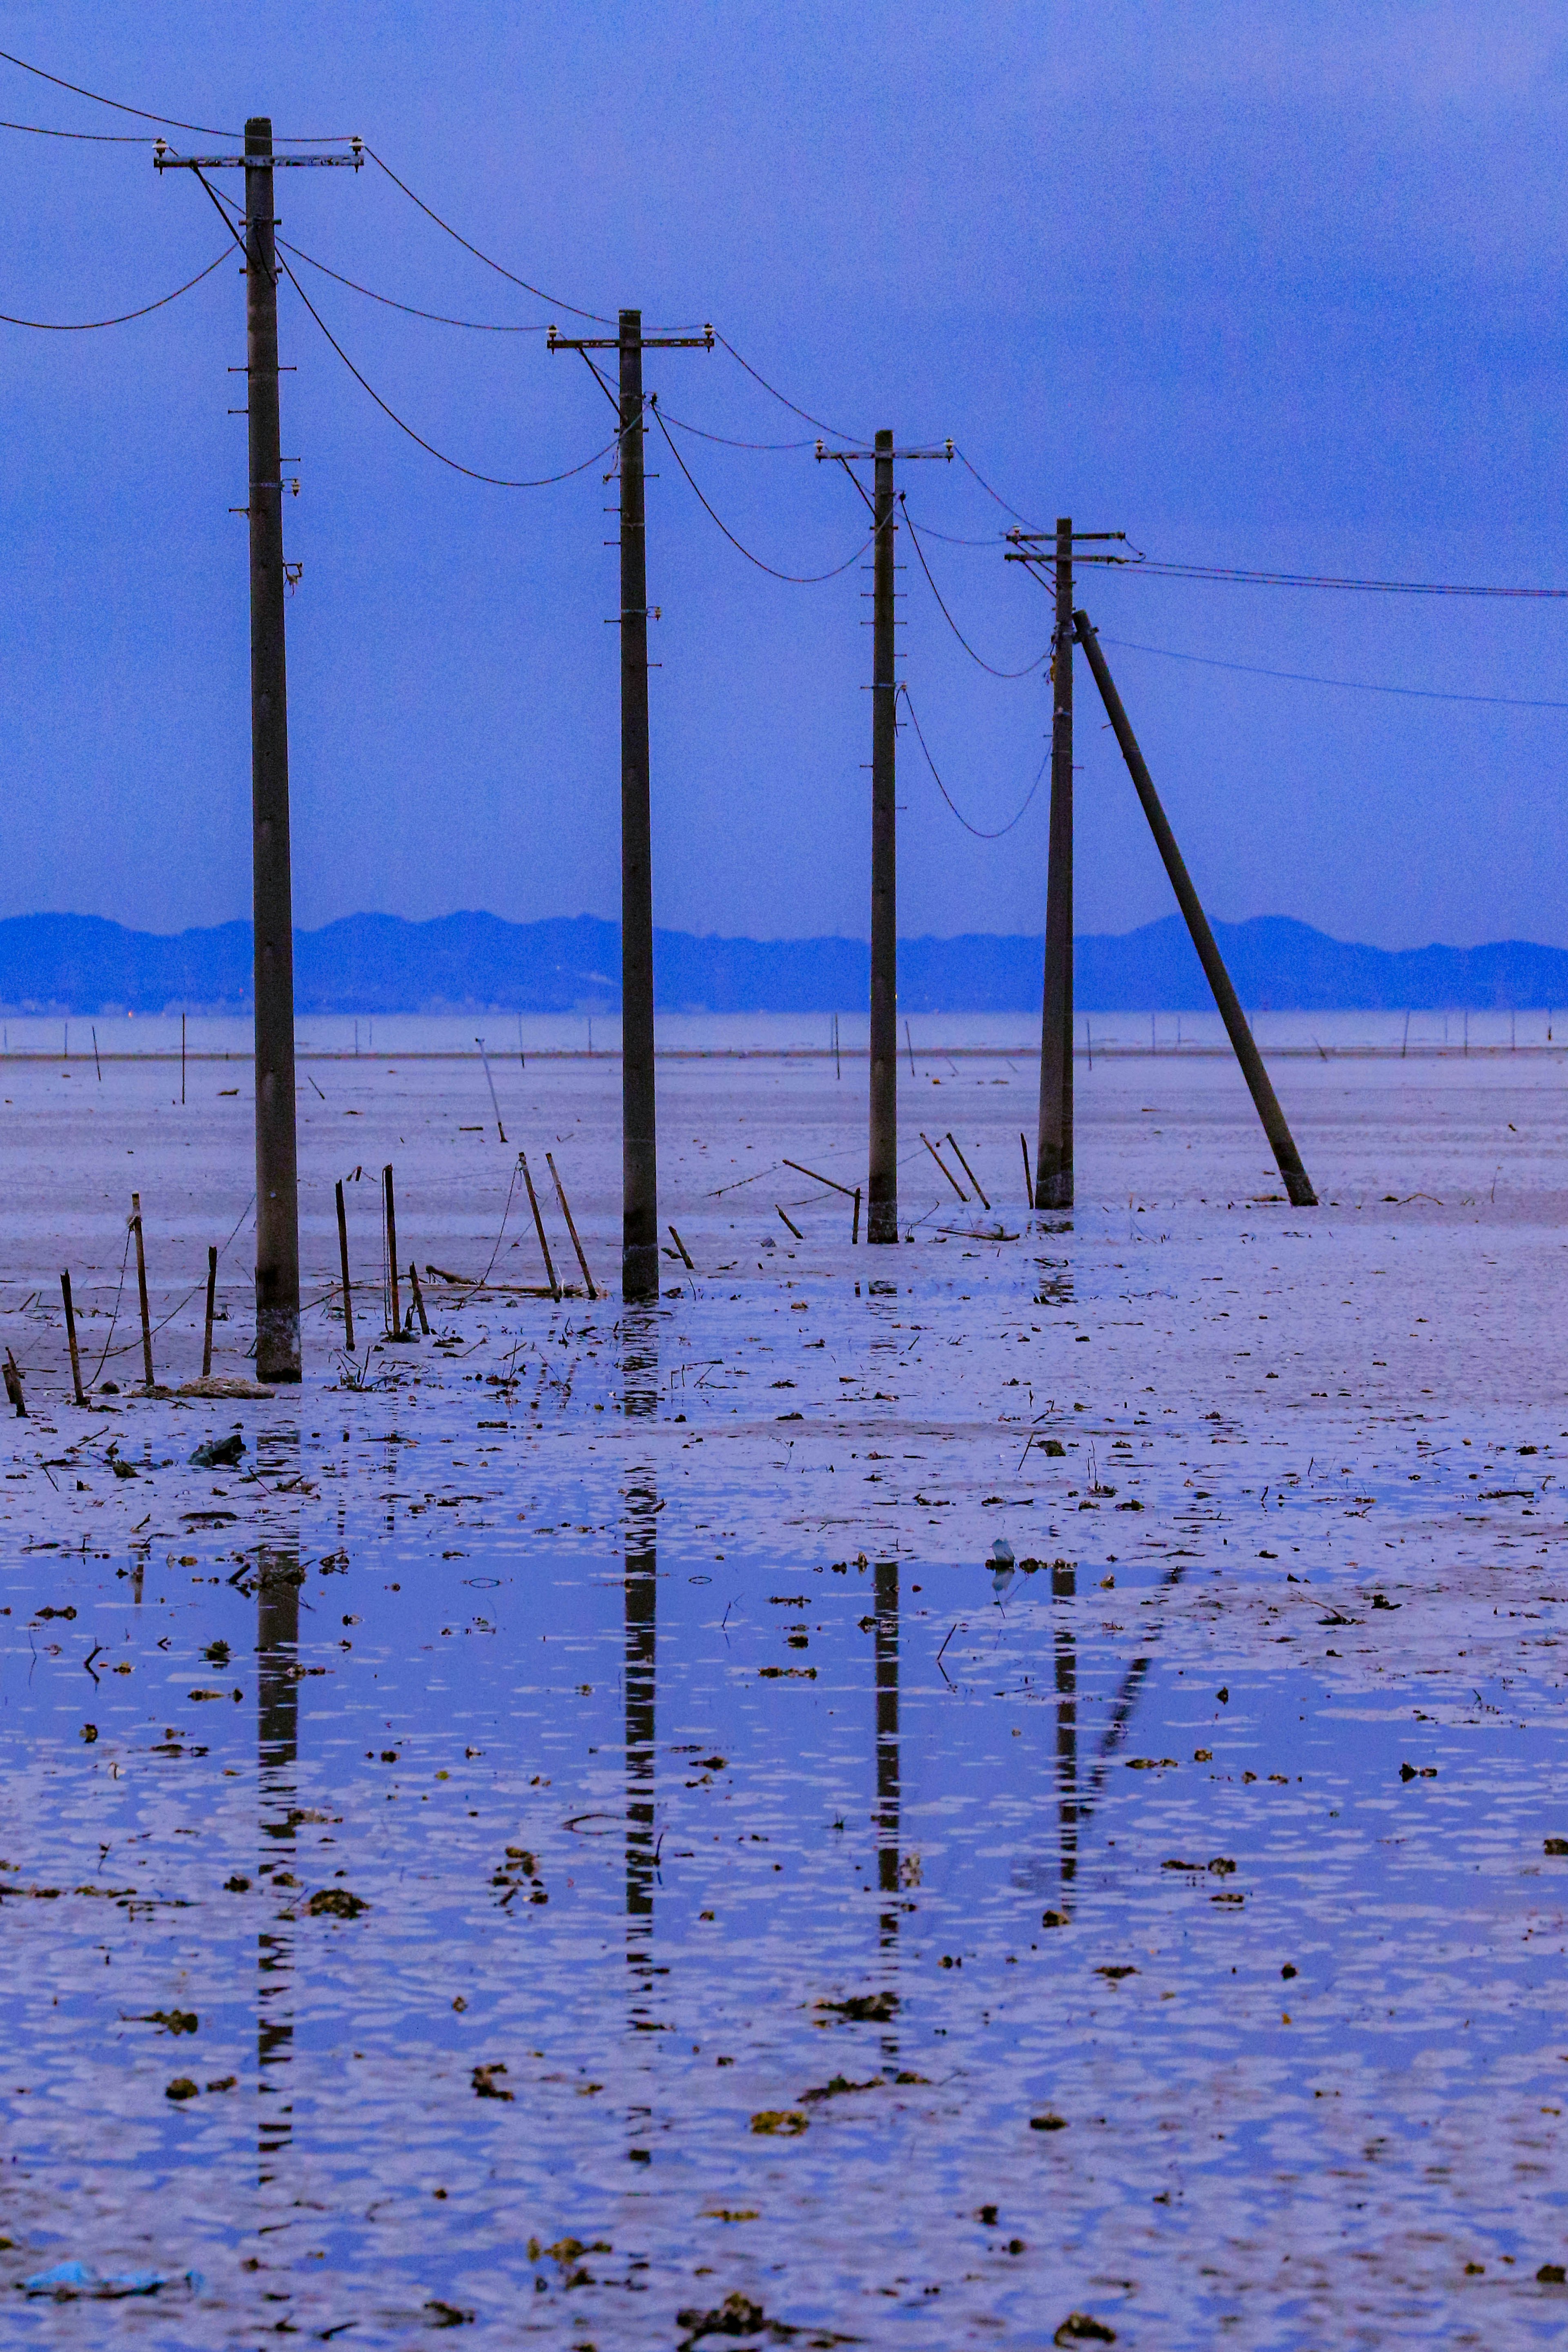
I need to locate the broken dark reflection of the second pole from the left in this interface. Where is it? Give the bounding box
[621,1305,658,2164]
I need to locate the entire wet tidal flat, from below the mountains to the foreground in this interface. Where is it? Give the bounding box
[0,1054,1568,2352]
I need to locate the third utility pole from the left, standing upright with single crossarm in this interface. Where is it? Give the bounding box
[816,430,952,1242]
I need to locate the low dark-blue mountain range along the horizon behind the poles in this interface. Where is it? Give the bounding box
[0,915,1568,1014]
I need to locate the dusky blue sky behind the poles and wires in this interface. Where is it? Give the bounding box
[0,0,1568,946]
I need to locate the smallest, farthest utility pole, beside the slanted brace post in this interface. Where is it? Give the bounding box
[1006,515,1126,1209]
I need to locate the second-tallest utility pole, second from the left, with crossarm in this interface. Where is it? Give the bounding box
[548,310,715,1298]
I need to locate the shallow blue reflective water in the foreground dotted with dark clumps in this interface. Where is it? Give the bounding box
[0,1475,1568,2352]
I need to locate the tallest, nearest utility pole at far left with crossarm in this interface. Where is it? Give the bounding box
[153,115,364,1381]
